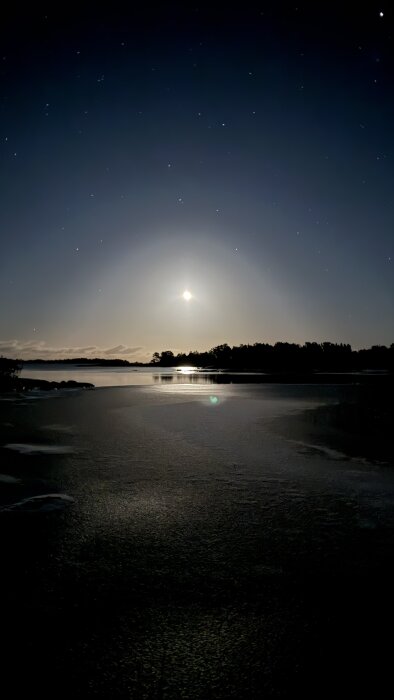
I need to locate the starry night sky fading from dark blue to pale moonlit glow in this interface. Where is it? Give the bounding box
[0,2,394,361]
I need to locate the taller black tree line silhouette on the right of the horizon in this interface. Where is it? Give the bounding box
[152,342,394,372]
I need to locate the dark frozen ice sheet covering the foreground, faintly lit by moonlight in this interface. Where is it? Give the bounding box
[0,385,394,700]
